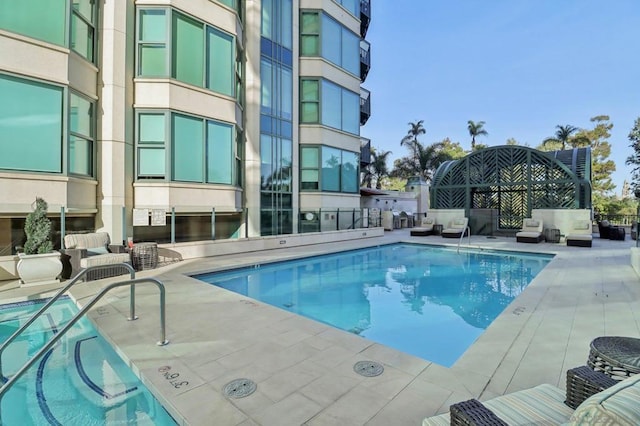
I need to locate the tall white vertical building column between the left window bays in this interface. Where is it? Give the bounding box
[96,0,135,243]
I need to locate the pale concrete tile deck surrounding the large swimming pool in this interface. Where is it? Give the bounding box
[0,229,640,425]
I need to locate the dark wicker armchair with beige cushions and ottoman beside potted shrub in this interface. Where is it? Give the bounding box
[60,232,131,281]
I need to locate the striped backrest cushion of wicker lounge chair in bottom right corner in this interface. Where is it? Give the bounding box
[570,374,640,426]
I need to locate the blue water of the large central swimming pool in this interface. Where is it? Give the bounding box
[196,244,553,367]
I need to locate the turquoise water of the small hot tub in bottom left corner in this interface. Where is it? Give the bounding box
[0,298,176,426]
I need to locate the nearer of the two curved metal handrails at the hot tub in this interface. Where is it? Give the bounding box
[0,276,169,406]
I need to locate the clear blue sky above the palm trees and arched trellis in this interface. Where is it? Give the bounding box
[360,0,640,195]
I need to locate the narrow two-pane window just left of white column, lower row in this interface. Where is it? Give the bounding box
[69,93,94,176]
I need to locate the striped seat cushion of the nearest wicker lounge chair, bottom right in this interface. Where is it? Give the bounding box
[422,384,573,426]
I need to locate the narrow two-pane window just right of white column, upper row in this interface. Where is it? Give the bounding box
[138,9,169,77]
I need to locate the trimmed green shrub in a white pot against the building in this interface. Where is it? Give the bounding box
[17,197,62,286]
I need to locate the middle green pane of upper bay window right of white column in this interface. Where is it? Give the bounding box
[171,12,204,87]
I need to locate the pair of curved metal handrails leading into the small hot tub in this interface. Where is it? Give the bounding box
[0,263,169,406]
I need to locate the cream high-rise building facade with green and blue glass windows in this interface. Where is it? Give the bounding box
[0,0,370,256]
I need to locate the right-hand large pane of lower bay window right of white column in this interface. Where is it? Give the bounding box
[207,121,234,185]
